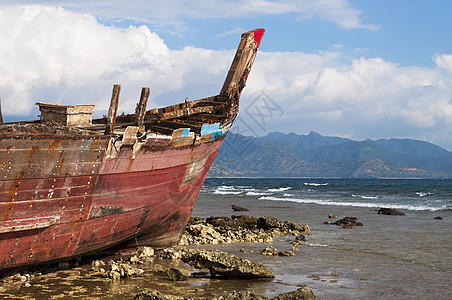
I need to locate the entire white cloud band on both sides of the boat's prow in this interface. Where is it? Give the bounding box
[0,6,452,149]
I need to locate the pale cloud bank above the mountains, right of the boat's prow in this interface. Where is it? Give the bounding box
[238,47,452,149]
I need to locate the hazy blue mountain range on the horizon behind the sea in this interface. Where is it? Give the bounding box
[209,132,452,178]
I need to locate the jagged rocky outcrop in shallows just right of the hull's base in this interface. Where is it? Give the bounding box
[179,215,311,245]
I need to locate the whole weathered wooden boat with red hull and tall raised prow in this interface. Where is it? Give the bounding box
[0,29,264,270]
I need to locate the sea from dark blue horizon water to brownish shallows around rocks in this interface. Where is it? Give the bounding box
[192,178,452,299]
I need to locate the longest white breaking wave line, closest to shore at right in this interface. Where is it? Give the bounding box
[259,196,450,211]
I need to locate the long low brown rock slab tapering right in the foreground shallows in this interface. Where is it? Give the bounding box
[182,249,275,278]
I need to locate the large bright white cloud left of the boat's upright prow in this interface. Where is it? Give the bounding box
[0,6,233,115]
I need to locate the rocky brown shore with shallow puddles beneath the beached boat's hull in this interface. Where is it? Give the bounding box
[0,214,318,300]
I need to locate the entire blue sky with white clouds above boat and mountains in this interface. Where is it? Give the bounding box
[0,0,452,151]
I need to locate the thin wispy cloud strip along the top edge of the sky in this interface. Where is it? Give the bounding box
[2,0,377,31]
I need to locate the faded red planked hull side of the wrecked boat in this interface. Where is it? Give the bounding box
[0,134,223,269]
